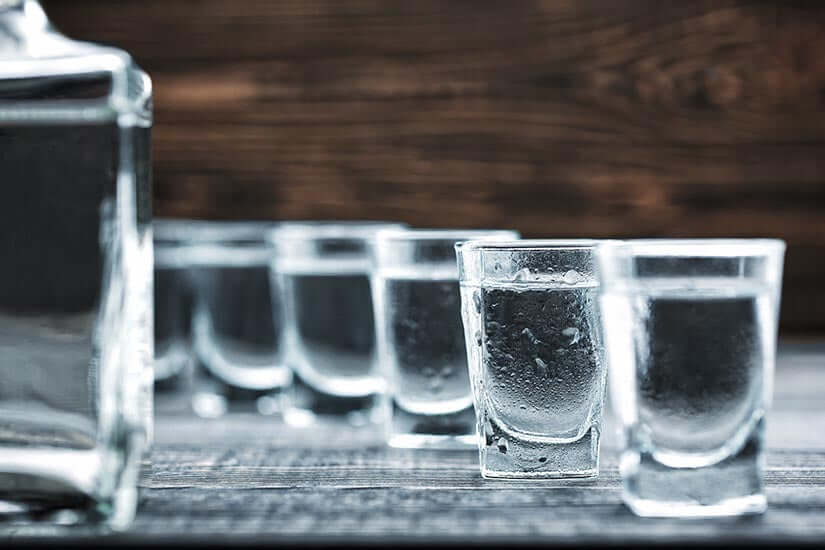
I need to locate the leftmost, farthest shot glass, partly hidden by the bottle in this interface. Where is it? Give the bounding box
[152,219,198,393]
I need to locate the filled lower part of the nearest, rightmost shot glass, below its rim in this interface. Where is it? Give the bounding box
[602,278,775,516]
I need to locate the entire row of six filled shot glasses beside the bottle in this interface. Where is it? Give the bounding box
[155,220,784,516]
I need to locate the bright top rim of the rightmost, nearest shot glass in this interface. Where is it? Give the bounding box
[599,238,787,258]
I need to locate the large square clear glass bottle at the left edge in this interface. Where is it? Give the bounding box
[0,0,152,528]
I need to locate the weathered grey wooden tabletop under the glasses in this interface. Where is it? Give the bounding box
[9,342,825,545]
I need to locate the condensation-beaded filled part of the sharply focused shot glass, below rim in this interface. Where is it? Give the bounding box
[465,282,606,477]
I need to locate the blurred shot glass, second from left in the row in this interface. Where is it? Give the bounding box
[187,222,291,417]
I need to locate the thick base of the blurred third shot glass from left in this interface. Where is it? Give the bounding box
[284,373,388,428]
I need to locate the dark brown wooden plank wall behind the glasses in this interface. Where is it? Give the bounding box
[44,0,825,334]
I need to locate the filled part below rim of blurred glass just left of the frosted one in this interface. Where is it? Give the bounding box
[378,269,476,448]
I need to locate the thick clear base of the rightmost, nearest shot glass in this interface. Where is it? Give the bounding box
[620,430,767,518]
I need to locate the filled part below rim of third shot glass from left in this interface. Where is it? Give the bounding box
[277,263,383,426]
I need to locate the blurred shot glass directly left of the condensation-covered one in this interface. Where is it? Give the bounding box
[372,229,519,449]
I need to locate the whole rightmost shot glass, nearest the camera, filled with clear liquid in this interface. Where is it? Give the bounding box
[598,239,785,517]
